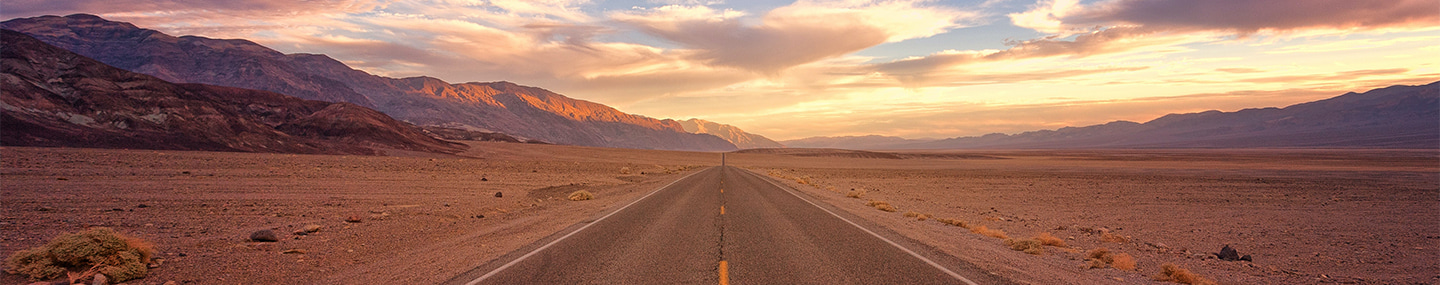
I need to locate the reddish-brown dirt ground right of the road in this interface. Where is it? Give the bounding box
[729,150,1440,284]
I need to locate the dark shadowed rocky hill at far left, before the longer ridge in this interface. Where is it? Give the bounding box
[0,30,465,154]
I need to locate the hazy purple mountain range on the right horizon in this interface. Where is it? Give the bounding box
[887,82,1440,148]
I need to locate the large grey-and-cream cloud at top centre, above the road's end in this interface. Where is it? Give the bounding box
[611,0,979,75]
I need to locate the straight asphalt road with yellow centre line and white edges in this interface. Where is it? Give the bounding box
[448,167,1008,285]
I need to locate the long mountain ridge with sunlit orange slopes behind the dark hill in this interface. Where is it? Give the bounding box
[0,14,736,151]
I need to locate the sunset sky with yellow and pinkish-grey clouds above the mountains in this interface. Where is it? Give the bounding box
[0,0,1440,140]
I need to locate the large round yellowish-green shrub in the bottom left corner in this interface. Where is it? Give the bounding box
[6,227,156,282]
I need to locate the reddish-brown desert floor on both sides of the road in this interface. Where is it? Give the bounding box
[0,143,1440,284]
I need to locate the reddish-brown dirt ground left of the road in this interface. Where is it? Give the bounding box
[0,143,720,284]
